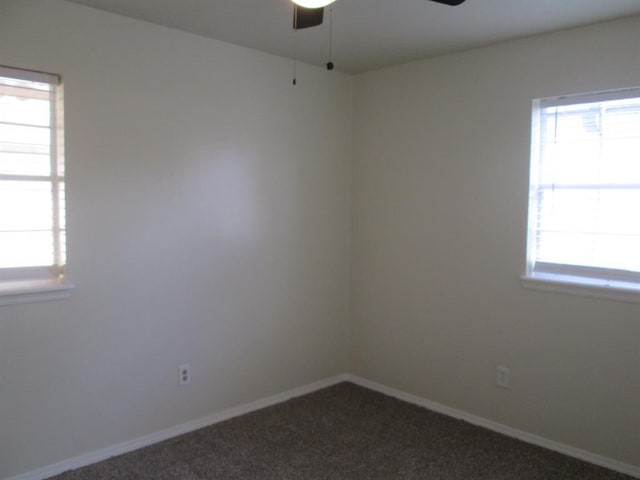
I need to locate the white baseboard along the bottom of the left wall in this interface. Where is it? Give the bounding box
[5,375,347,480]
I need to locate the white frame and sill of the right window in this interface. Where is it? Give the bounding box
[521,87,640,303]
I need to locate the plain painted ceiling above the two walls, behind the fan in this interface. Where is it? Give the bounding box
[69,0,640,73]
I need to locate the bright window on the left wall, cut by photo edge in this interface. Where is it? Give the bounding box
[0,66,69,303]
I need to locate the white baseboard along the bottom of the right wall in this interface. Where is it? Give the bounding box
[346,375,640,478]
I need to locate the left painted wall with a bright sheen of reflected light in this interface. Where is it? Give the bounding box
[0,0,352,478]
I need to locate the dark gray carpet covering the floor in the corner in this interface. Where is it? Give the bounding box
[48,383,631,480]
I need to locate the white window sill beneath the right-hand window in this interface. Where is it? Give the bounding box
[522,275,640,303]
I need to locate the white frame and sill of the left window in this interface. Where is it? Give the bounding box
[0,65,74,306]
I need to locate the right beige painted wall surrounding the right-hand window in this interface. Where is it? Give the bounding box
[350,18,640,465]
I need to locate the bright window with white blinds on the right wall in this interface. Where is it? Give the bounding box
[525,88,640,301]
